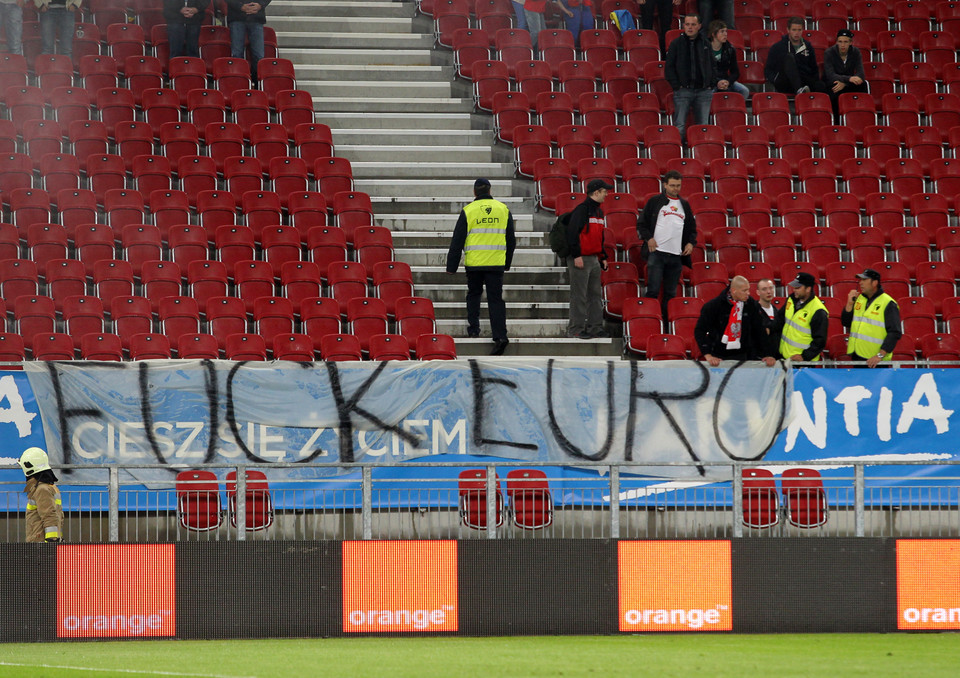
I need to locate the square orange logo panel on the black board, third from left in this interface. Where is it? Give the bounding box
[617,541,733,631]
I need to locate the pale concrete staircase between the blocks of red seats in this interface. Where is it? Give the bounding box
[268,0,621,356]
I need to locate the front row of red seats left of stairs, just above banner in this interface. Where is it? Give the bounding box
[0,332,457,362]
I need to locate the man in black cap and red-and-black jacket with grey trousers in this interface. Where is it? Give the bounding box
[567,179,613,339]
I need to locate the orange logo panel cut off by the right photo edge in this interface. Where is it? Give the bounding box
[897,539,960,630]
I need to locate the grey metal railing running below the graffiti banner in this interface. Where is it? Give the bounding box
[0,461,960,542]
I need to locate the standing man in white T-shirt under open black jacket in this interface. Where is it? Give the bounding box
[637,170,697,320]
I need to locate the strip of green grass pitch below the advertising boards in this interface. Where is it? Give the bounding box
[0,633,960,678]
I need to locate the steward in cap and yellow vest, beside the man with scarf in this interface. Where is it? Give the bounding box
[777,273,830,361]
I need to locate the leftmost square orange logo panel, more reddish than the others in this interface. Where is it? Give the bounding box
[57,544,177,638]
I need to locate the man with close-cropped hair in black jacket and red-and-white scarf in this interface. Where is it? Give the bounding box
[693,275,776,367]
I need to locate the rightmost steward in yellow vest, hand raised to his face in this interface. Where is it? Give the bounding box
[840,268,903,367]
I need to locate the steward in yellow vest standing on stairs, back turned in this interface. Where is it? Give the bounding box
[447,178,516,355]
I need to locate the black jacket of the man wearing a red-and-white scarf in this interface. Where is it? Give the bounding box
[693,286,776,360]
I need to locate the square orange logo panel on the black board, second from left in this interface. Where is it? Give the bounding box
[343,541,460,633]
